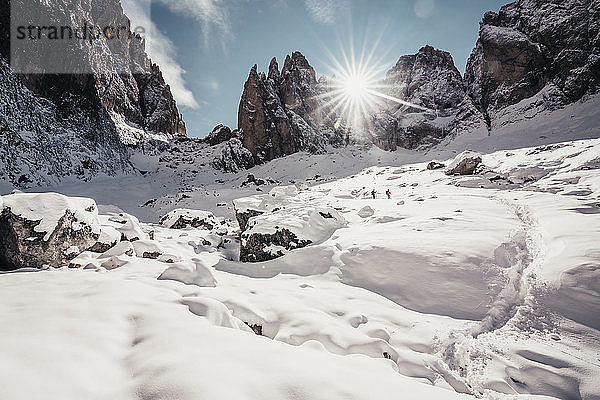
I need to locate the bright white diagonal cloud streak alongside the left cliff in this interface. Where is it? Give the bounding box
[122,0,200,108]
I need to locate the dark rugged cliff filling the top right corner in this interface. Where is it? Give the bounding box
[465,0,600,119]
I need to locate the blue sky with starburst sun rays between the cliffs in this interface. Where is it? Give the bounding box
[129,0,506,137]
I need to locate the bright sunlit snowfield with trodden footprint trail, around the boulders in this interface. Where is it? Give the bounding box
[0,93,600,400]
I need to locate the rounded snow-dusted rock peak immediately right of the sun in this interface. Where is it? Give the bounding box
[374,46,483,150]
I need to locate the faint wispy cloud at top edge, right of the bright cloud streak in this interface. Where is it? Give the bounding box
[155,0,234,48]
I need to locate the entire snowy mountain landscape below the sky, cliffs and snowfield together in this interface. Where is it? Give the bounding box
[0,0,600,400]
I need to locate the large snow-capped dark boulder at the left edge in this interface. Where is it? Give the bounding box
[0,193,100,270]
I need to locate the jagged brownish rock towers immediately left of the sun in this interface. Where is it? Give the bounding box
[238,52,342,163]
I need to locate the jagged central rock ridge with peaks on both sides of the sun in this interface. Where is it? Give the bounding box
[238,46,484,159]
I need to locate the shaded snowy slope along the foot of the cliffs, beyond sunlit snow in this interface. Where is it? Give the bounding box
[22,93,600,222]
